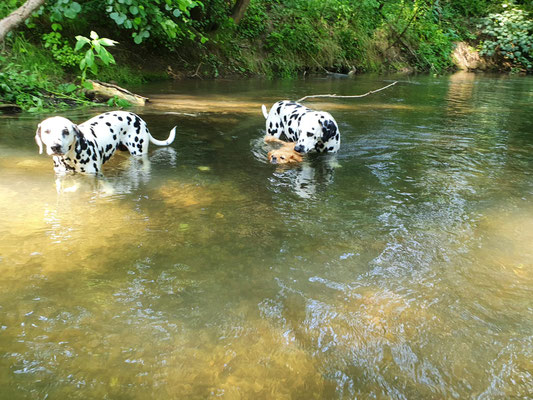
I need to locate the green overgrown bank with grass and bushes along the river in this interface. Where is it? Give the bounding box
[0,0,533,110]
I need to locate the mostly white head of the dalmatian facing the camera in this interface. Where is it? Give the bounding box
[35,117,81,156]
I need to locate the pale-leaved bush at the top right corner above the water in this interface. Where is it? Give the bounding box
[481,4,533,71]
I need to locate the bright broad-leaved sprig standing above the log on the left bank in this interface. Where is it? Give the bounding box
[74,31,118,88]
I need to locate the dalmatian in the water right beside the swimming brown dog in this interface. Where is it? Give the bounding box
[262,100,340,154]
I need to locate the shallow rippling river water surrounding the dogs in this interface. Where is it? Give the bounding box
[0,73,533,399]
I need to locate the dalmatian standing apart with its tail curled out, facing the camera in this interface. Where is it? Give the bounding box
[35,111,176,174]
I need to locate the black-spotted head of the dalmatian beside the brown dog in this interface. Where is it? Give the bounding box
[294,112,338,154]
